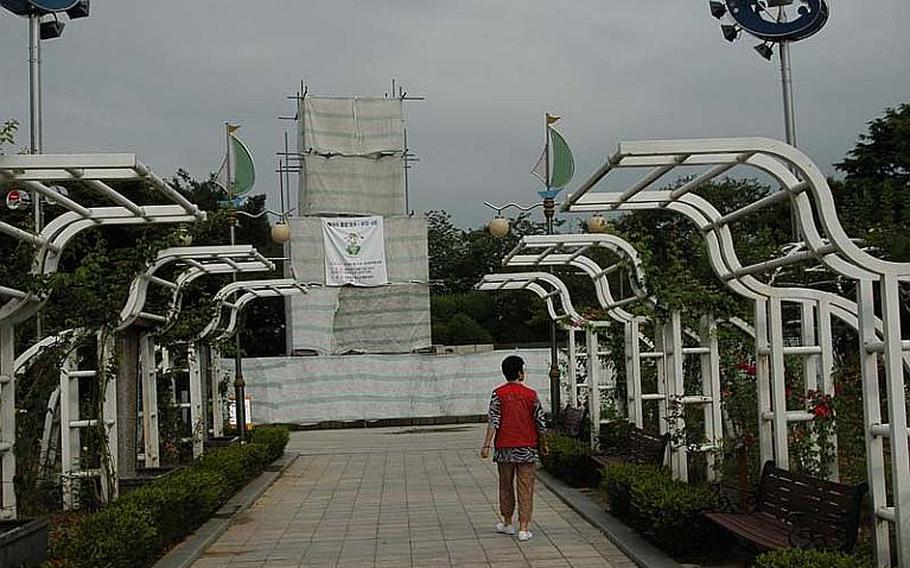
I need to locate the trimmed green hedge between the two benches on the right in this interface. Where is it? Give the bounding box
[601,464,720,555]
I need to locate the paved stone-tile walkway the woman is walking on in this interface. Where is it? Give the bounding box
[193,424,634,568]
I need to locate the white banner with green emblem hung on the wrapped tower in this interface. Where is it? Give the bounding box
[322,216,389,286]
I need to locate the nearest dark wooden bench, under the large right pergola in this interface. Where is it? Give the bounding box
[705,461,868,552]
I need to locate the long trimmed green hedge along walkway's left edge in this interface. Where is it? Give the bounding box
[51,426,289,568]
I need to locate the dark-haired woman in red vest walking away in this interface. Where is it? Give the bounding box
[480,355,547,542]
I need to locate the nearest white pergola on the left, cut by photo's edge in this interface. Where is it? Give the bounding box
[0,154,205,518]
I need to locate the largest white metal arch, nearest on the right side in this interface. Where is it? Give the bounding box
[563,138,910,566]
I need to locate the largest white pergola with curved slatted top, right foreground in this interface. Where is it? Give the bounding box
[563,138,910,566]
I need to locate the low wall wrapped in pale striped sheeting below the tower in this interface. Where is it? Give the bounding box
[223,349,549,424]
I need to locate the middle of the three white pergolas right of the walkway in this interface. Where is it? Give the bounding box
[503,234,732,481]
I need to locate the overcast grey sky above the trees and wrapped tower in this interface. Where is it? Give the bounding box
[0,0,910,229]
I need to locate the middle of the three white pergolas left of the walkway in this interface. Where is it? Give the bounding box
[114,245,275,462]
